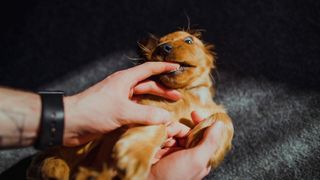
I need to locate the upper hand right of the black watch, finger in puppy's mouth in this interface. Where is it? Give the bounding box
[64,62,181,146]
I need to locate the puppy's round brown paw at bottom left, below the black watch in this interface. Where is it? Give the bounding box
[41,157,70,180]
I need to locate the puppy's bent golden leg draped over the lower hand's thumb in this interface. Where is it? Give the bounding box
[187,113,234,168]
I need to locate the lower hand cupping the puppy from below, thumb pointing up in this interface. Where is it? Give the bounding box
[149,112,224,180]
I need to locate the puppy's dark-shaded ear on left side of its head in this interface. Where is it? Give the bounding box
[138,34,159,60]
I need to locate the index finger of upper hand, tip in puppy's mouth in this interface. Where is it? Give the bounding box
[125,62,180,85]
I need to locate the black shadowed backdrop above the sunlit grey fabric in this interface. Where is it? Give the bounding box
[0,0,320,89]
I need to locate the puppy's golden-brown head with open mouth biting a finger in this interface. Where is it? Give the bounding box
[139,31,214,88]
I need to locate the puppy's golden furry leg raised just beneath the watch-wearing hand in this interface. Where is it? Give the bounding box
[113,125,167,180]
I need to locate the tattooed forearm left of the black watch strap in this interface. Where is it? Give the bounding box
[0,87,41,149]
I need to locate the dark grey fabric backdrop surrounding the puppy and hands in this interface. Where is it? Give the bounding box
[0,0,320,179]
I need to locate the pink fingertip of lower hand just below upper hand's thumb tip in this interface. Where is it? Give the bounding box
[167,122,190,138]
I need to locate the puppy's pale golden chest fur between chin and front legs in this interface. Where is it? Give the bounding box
[139,86,225,127]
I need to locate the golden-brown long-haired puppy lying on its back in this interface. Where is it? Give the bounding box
[27,31,233,180]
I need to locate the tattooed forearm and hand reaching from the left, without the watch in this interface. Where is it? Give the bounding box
[0,62,180,149]
